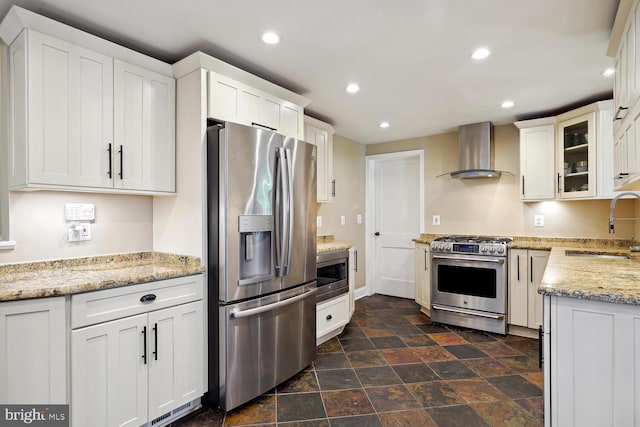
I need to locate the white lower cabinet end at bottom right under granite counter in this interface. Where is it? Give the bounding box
[544,296,640,427]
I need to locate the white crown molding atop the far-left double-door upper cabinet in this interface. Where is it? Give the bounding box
[0,5,173,77]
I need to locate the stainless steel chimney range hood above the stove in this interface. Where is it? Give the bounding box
[450,122,502,179]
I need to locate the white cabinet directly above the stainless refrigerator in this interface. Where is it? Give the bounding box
[207,71,304,139]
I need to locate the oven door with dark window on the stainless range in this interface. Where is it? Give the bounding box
[431,255,507,314]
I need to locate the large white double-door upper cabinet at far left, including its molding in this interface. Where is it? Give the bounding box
[0,7,175,194]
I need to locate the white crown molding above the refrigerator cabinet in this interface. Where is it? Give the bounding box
[173,51,311,108]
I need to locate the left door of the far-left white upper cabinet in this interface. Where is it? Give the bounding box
[25,30,113,187]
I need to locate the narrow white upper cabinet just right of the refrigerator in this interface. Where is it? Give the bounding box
[304,116,336,202]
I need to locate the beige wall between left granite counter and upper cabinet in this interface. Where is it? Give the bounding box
[0,191,153,264]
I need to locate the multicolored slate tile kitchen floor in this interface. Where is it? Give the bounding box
[176,295,543,427]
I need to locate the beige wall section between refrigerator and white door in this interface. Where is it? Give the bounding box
[318,135,365,288]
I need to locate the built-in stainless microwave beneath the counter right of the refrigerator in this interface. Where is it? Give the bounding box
[316,249,349,303]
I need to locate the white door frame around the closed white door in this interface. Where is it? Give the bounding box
[364,149,425,298]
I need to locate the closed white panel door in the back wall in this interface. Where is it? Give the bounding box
[373,156,421,299]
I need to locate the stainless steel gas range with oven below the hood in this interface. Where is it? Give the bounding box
[431,236,512,334]
